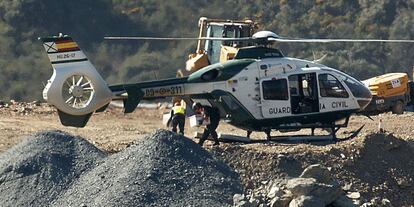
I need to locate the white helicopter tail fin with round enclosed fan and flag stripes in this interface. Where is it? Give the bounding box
[39,34,112,127]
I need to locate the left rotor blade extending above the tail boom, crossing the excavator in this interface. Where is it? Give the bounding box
[104,37,253,41]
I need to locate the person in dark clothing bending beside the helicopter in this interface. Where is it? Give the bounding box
[193,102,220,146]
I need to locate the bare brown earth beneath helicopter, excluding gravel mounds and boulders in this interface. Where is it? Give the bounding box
[0,103,414,206]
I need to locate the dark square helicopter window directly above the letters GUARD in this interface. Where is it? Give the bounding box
[262,79,289,100]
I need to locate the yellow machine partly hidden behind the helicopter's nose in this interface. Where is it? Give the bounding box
[362,73,414,115]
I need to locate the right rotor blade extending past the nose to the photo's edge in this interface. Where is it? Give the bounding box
[267,37,414,43]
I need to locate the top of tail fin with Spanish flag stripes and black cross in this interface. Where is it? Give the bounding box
[40,35,88,64]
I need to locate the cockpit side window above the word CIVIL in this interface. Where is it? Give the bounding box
[318,74,349,98]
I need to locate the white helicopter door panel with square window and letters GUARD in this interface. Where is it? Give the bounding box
[260,78,291,118]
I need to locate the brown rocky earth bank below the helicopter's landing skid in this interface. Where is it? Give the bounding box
[212,133,414,206]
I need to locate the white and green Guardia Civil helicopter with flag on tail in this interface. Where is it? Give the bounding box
[39,31,414,141]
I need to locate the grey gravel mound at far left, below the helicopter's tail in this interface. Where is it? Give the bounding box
[0,131,104,206]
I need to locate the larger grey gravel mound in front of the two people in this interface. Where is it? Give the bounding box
[54,130,242,206]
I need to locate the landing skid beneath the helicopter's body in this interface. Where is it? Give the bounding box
[219,125,365,144]
